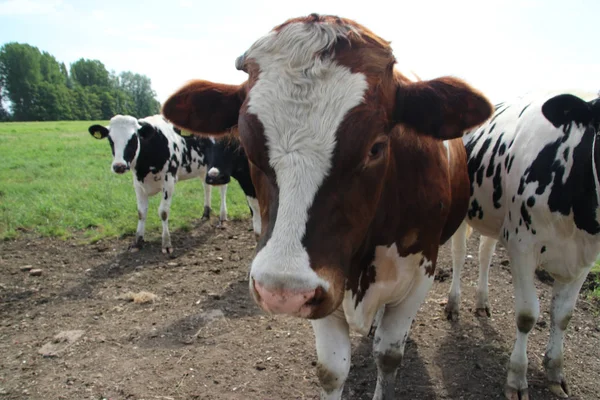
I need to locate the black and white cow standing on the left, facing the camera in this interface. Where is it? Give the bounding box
[88,115,227,253]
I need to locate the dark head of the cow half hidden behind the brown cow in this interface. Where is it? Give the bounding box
[206,135,248,185]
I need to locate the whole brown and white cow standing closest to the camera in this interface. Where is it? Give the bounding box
[163,14,492,399]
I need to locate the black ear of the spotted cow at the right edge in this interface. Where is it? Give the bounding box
[542,94,600,128]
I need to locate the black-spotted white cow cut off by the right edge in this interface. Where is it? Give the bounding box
[446,93,600,400]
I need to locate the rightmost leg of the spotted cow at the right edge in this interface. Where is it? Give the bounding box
[544,268,590,398]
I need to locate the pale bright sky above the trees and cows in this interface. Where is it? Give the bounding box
[0,0,600,102]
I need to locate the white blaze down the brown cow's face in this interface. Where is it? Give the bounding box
[245,23,368,289]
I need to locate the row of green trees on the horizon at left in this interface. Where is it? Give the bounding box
[0,42,160,121]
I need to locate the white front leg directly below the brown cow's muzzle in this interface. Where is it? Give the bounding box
[311,310,350,400]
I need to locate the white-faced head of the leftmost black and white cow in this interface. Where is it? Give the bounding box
[88,115,156,174]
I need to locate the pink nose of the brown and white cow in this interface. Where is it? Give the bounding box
[254,281,316,317]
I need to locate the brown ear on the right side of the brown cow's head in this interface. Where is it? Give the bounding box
[394,77,493,140]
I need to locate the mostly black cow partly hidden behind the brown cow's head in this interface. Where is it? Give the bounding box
[206,135,261,235]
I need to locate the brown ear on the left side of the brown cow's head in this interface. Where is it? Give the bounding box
[162,80,246,135]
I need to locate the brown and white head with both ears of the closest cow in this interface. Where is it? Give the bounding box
[163,14,492,318]
